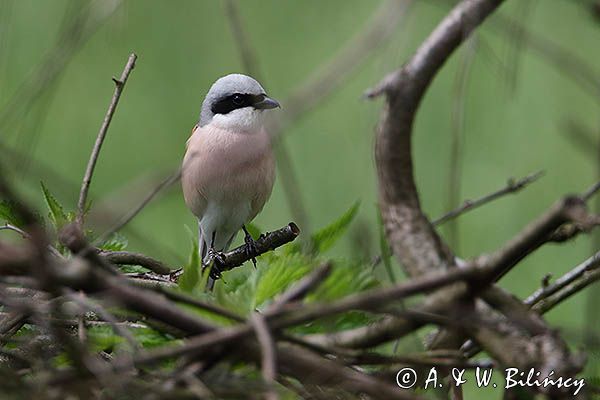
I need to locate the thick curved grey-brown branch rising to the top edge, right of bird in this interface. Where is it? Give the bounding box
[367,0,502,276]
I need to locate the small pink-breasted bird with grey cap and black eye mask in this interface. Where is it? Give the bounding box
[181,74,279,289]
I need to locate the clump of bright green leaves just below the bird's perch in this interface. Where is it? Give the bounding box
[179,198,379,333]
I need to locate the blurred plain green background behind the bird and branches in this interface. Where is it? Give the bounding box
[0,0,600,398]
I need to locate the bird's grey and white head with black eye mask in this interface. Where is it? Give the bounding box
[200,74,279,131]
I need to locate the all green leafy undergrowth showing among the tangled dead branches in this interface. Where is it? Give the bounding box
[0,183,386,358]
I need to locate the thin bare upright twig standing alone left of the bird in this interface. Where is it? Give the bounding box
[77,53,137,224]
